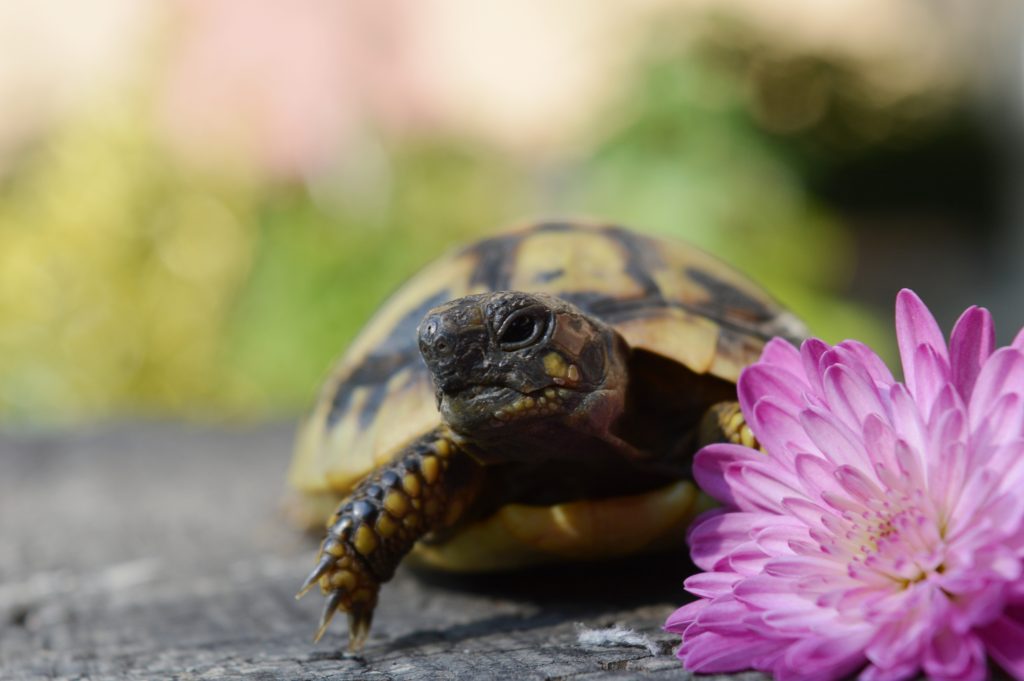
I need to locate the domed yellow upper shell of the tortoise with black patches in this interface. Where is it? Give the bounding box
[289,222,804,517]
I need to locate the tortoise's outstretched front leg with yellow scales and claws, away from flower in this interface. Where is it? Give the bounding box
[296,428,482,651]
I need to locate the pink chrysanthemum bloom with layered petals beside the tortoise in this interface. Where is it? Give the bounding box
[666,291,1024,681]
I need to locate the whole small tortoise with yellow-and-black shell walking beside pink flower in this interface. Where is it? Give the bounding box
[289,222,806,650]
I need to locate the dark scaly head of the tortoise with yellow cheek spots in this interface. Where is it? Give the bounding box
[418,291,627,437]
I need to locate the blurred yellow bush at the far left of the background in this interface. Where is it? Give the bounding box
[0,111,251,421]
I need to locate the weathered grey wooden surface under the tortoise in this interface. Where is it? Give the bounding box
[0,425,764,680]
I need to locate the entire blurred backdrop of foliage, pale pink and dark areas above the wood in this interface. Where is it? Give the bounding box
[0,0,1024,428]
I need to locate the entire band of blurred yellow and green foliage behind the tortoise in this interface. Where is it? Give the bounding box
[0,37,889,423]
